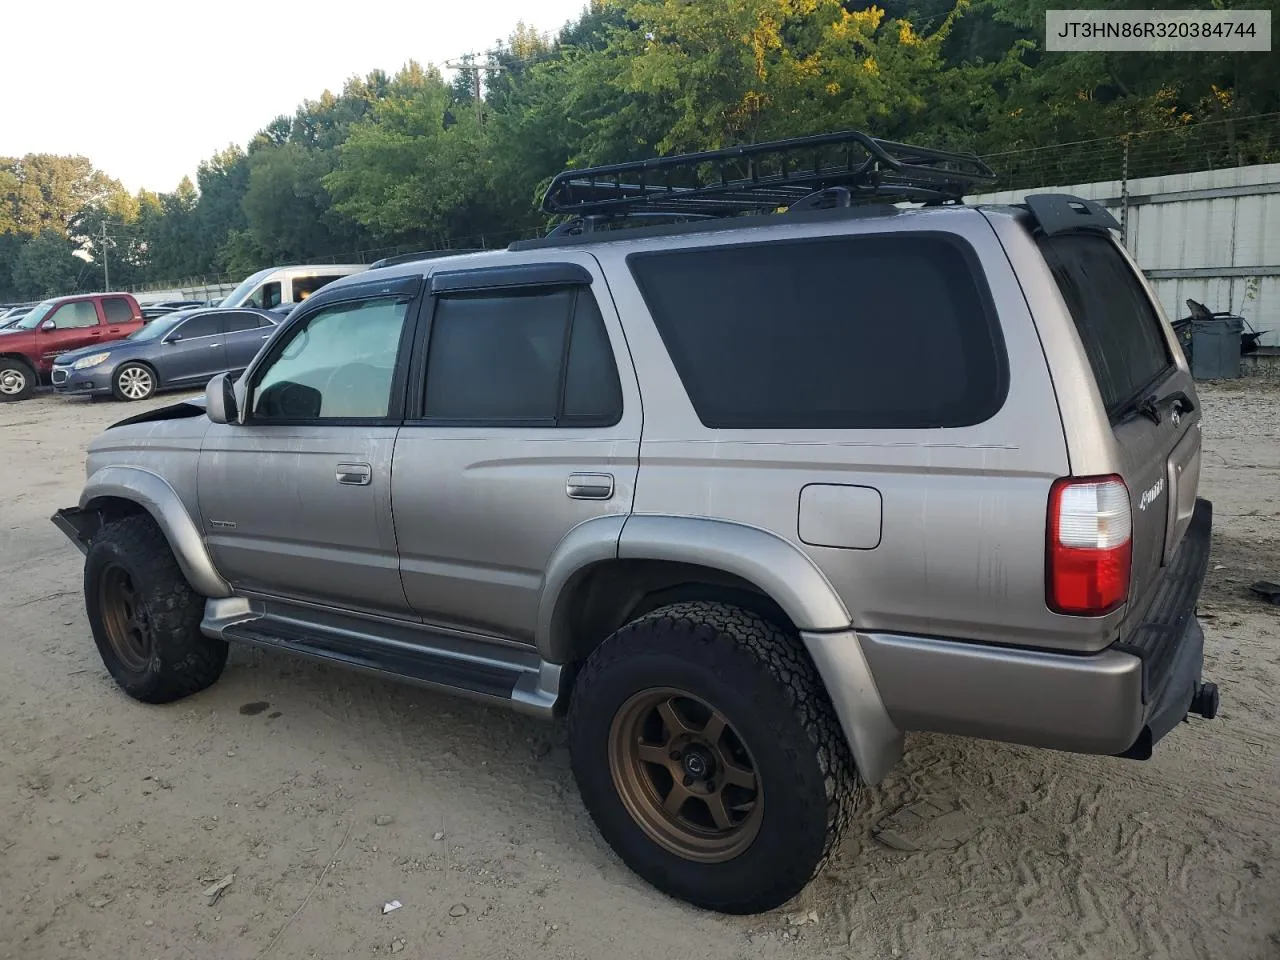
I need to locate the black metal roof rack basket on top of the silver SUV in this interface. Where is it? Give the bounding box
[543,131,996,227]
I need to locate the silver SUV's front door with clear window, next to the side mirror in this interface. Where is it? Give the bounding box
[198,285,412,616]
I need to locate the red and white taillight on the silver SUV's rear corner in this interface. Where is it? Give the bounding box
[1044,476,1133,617]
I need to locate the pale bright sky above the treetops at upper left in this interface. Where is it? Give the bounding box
[0,0,588,192]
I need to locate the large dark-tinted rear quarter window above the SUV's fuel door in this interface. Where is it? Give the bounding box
[628,233,1009,429]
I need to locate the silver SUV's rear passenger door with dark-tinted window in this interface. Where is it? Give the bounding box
[392,255,640,643]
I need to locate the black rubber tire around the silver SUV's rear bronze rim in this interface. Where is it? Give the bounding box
[568,602,861,914]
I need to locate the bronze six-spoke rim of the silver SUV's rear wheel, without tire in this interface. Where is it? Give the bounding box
[609,687,764,863]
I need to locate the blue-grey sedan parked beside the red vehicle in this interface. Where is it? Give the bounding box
[51,307,282,401]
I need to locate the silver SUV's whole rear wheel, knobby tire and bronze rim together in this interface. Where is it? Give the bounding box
[570,603,858,914]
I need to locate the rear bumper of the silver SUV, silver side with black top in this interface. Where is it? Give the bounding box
[860,500,1216,759]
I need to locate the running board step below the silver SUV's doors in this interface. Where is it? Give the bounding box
[201,602,559,718]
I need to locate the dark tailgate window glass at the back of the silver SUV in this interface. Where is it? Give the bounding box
[1039,234,1174,413]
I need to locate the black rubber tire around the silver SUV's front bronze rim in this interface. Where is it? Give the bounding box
[84,516,227,703]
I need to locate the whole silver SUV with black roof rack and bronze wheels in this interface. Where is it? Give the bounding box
[54,133,1217,913]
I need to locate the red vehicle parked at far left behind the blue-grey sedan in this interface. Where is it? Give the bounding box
[0,293,143,401]
